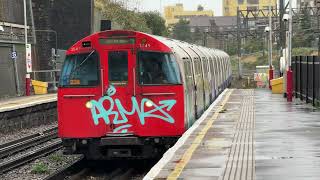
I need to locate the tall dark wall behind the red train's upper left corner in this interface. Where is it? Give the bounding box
[32,0,93,70]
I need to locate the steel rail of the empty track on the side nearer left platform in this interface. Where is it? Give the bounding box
[0,127,58,158]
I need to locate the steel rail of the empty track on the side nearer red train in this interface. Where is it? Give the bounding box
[0,139,62,174]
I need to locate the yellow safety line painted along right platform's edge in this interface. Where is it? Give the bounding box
[167,89,233,180]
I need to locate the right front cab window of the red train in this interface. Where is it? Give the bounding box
[138,51,181,85]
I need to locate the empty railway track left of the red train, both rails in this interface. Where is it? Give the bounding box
[0,128,62,174]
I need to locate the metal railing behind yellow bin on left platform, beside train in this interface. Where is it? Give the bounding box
[31,69,60,91]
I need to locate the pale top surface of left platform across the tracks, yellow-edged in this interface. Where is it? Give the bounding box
[0,94,57,113]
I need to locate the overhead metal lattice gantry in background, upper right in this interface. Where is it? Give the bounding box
[209,4,320,77]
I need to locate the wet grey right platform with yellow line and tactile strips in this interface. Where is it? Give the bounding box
[144,89,320,180]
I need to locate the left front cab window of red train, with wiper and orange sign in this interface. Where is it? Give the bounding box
[59,51,100,87]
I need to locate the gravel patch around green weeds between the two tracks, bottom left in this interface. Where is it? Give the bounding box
[0,150,80,180]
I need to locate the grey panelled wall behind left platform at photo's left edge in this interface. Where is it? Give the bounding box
[0,0,30,99]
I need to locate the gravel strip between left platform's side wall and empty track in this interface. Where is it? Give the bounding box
[0,122,57,145]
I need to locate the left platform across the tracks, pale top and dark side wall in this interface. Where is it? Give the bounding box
[0,94,57,134]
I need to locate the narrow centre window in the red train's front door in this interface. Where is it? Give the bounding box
[108,51,128,85]
